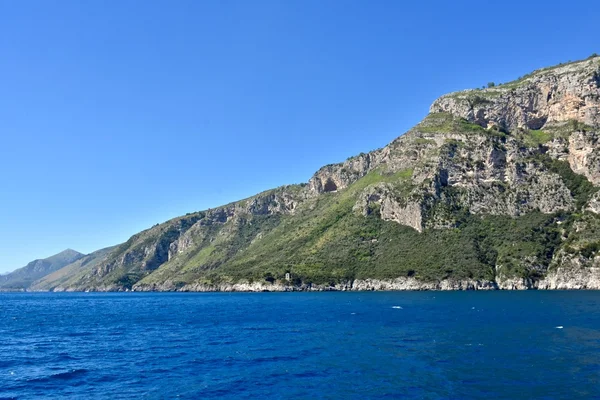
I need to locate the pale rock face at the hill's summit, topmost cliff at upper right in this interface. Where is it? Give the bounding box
[430,57,600,131]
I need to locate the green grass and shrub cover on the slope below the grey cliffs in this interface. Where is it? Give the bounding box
[132,165,576,284]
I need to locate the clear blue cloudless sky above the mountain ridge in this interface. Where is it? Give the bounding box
[0,0,600,272]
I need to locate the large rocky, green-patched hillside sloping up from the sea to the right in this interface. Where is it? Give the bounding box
[10,57,600,291]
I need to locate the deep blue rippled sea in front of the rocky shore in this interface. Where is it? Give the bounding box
[0,292,600,399]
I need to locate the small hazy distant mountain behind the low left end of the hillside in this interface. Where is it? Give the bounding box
[0,249,84,290]
